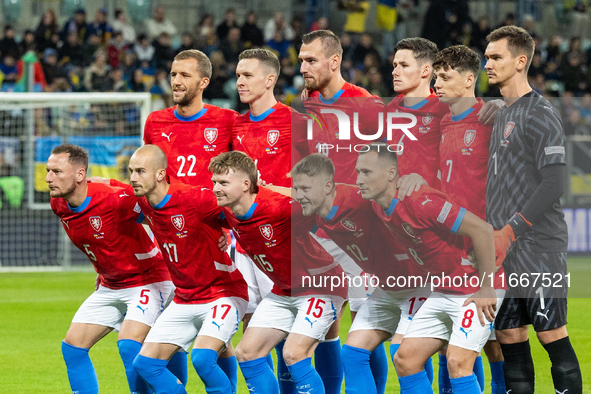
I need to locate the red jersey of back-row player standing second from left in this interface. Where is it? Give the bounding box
[232,102,306,187]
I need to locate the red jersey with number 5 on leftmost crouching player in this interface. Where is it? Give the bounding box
[51,183,170,289]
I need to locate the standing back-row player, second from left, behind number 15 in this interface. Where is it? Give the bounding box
[232,49,307,393]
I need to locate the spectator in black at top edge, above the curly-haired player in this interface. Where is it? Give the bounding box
[422,0,471,49]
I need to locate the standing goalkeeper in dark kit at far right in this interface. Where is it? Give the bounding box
[485,26,582,394]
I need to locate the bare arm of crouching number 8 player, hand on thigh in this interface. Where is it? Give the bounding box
[457,211,497,326]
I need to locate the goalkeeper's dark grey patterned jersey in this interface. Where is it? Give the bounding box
[486,91,568,252]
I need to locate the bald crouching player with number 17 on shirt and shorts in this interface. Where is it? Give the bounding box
[129,145,248,394]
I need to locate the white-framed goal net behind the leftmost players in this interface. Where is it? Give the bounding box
[0,93,151,271]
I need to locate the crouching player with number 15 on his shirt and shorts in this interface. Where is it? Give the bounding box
[209,151,346,394]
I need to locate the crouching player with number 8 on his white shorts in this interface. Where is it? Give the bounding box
[354,143,504,394]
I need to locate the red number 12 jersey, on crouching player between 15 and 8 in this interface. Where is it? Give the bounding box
[315,184,424,290]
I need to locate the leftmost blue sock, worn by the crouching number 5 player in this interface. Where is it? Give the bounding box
[62,342,98,394]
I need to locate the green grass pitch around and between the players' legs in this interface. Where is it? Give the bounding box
[0,258,591,394]
